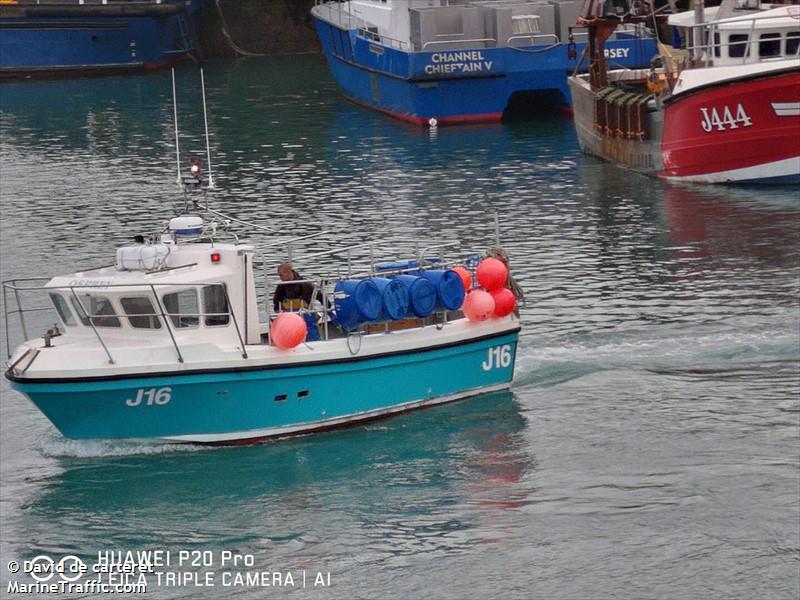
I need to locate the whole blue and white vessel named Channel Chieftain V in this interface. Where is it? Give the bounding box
[311,0,656,124]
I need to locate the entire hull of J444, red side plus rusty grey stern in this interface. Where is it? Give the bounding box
[569,67,800,184]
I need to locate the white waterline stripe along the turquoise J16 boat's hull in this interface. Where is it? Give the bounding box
[161,382,511,444]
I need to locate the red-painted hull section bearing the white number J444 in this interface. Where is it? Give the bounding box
[661,69,800,177]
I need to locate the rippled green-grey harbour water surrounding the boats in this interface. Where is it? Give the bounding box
[0,55,800,600]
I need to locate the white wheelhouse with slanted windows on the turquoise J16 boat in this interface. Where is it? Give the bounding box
[45,217,262,345]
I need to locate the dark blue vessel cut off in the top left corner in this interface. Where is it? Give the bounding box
[0,0,200,77]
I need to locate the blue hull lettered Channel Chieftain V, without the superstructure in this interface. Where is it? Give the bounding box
[312,11,656,125]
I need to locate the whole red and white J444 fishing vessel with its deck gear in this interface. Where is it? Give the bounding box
[569,0,800,183]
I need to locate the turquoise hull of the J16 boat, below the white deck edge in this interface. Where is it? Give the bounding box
[6,330,518,443]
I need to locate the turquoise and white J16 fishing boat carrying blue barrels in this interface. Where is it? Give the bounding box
[3,210,520,443]
